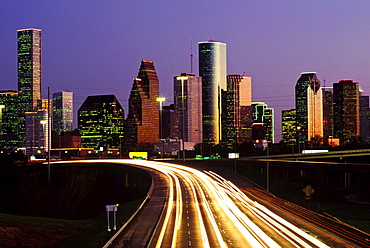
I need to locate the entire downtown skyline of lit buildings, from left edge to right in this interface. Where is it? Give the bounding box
[0,29,370,157]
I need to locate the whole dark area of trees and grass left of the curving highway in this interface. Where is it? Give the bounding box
[0,154,151,247]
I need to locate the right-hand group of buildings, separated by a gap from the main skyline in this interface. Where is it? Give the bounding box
[282,72,370,150]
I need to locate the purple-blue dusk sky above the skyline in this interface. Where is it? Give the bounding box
[0,0,370,142]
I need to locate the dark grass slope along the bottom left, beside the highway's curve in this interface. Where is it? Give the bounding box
[0,199,143,248]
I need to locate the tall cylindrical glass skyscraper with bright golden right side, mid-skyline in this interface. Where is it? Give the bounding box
[198,40,226,144]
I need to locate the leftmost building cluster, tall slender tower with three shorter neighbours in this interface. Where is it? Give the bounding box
[0,28,73,156]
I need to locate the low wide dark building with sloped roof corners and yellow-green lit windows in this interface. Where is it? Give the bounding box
[78,95,124,149]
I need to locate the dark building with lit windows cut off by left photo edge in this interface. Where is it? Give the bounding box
[0,90,22,147]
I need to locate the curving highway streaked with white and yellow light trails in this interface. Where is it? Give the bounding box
[53,159,368,248]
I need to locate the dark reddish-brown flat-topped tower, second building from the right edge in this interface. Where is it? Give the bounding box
[333,80,360,144]
